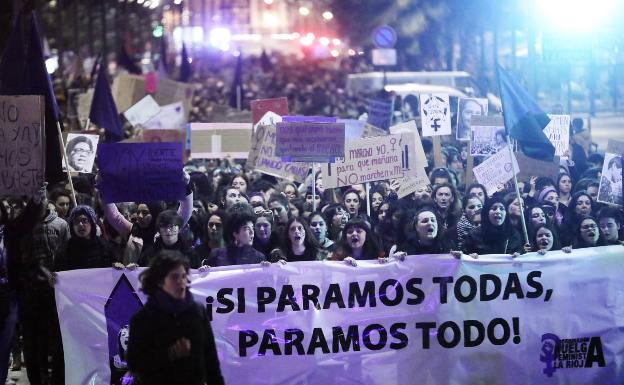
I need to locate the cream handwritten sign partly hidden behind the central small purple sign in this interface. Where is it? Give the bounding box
[247,112,312,182]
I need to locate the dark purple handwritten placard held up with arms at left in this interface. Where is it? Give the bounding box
[98,143,186,203]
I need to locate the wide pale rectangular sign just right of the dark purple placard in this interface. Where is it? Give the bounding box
[191,123,251,159]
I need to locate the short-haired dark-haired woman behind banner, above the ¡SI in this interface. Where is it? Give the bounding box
[207,210,266,266]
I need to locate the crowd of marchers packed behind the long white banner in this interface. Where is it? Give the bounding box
[0,51,623,384]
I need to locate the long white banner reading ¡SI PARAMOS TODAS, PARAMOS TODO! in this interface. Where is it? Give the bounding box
[56,246,624,385]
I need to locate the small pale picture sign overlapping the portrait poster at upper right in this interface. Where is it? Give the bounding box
[470,115,507,156]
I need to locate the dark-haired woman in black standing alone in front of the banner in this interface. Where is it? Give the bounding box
[127,250,224,385]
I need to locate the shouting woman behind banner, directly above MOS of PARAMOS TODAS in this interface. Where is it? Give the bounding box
[329,218,385,266]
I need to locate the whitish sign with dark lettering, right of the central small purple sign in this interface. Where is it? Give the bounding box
[322,133,418,188]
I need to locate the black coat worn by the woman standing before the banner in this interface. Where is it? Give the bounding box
[128,293,224,385]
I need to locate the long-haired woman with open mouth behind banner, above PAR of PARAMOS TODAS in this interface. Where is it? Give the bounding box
[271,218,327,262]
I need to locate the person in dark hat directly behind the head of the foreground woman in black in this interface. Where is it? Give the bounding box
[138,210,200,268]
